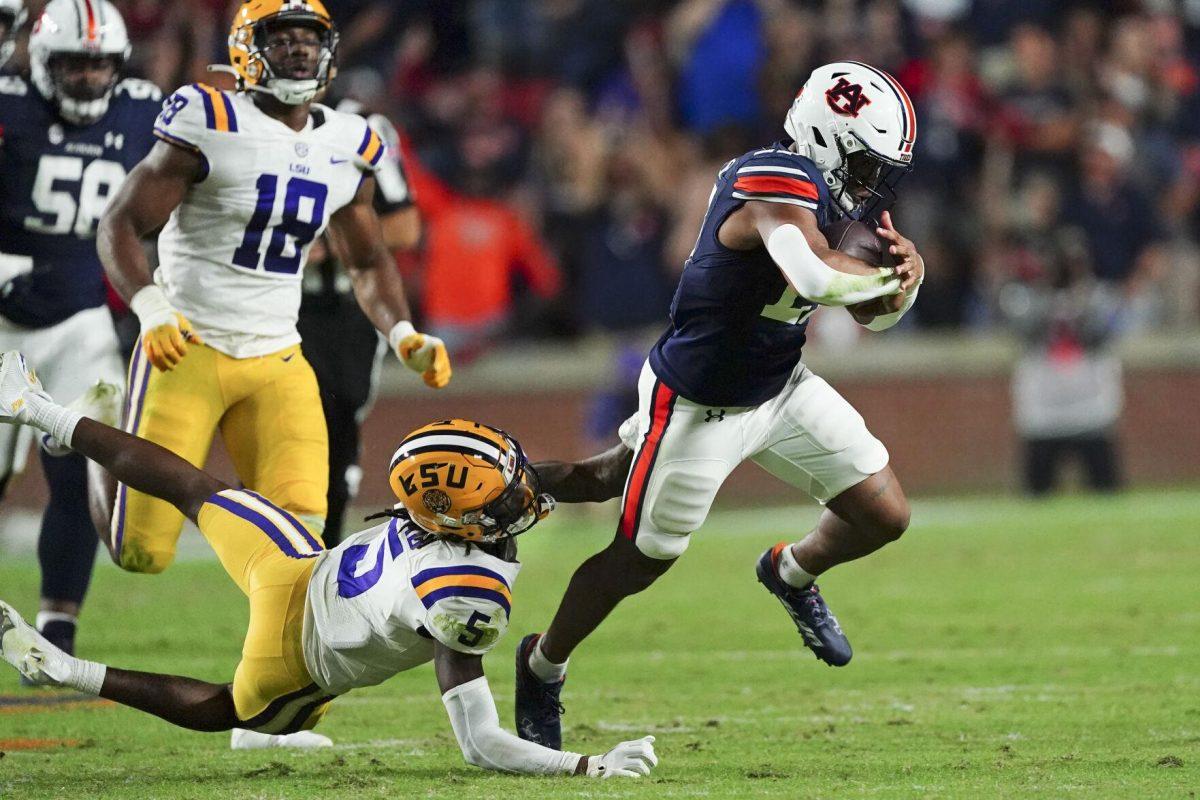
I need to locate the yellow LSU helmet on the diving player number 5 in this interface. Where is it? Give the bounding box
[389,420,554,542]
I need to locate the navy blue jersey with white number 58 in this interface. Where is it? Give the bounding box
[0,76,162,327]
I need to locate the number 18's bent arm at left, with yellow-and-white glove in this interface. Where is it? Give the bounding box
[96,142,205,369]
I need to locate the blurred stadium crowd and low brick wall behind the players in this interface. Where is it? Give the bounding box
[4,0,1200,515]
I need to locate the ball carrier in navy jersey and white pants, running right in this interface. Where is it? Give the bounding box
[516,62,924,747]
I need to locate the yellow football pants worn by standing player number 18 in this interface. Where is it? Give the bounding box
[110,342,329,572]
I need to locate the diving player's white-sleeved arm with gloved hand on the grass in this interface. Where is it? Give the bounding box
[433,642,659,777]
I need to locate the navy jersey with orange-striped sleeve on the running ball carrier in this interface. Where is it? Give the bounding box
[650,144,840,407]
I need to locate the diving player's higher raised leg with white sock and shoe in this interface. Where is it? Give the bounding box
[0,350,229,521]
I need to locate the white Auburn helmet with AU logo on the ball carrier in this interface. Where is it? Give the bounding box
[784,61,917,218]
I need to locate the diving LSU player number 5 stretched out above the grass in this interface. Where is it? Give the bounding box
[0,351,658,777]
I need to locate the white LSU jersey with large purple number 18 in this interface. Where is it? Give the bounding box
[155,84,386,359]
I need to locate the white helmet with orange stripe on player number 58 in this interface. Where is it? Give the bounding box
[29,0,131,125]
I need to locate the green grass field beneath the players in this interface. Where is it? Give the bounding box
[0,491,1200,800]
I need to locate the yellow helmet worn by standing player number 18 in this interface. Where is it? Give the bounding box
[224,0,337,106]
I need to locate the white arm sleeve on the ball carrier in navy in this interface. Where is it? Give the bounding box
[767,223,900,306]
